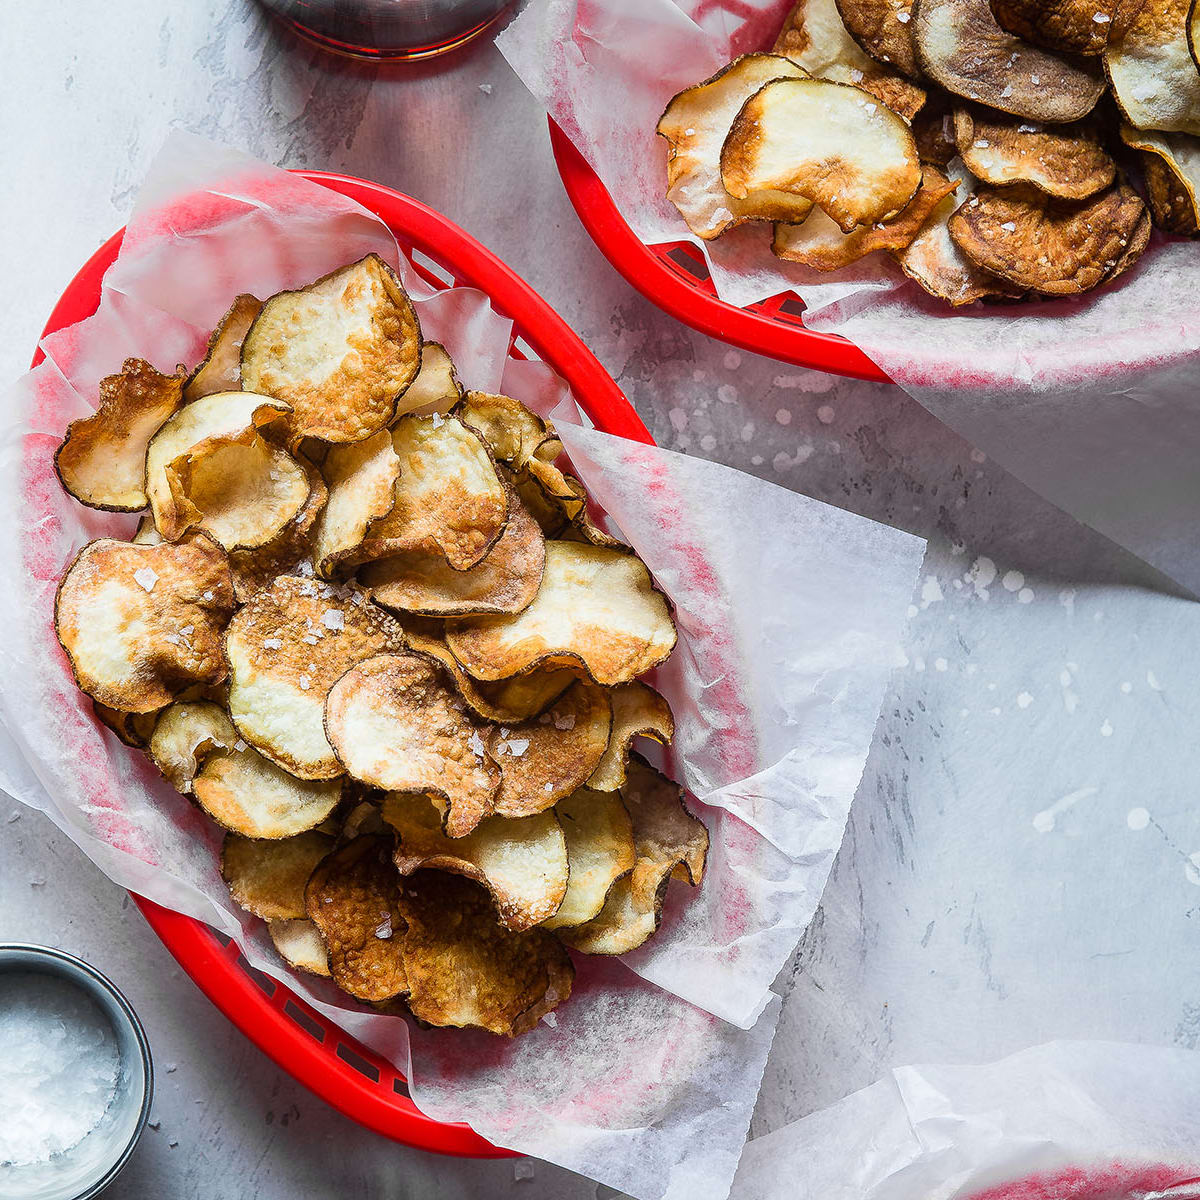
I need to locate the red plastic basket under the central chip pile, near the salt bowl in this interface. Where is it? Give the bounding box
[34,170,653,1158]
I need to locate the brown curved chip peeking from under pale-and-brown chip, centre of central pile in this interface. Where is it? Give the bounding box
[359,490,546,617]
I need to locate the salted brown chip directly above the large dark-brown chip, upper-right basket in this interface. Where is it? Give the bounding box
[954,107,1117,200]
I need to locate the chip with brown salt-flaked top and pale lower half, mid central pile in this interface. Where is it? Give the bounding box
[224,576,404,779]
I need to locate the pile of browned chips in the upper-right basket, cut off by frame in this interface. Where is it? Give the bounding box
[658,0,1200,306]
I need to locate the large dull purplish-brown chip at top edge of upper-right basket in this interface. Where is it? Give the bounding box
[912,0,1104,122]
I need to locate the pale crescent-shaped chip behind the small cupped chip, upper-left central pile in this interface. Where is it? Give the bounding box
[145,391,288,541]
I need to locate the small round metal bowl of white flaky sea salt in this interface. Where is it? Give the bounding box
[0,944,154,1200]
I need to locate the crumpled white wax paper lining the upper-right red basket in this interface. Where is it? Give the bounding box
[497,0,1200,593]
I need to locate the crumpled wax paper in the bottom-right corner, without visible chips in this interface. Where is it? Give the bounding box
[732,1042,1200,1200]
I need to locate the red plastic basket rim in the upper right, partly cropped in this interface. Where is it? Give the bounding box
[550,120,892,383]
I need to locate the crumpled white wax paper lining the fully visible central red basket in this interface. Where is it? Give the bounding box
[0,134,924,1200]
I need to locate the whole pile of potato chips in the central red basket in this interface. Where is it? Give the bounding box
[55,254,708,1036]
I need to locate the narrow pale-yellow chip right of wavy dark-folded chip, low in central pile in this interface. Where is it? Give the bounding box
[542,787,637,929]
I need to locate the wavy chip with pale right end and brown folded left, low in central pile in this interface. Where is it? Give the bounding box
[383,792,568,930]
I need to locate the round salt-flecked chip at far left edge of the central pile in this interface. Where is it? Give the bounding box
[54,534,233,713]
